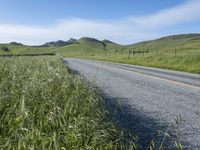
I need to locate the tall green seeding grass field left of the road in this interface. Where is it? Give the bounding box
[0,56,137,150]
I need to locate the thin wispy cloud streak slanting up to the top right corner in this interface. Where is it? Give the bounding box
[130,0,200,29]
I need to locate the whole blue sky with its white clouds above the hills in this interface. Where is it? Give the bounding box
[0,0,200,45]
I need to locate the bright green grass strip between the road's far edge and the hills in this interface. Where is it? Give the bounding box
[82,50,200,74]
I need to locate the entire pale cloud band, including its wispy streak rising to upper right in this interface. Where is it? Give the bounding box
[0,0,200,45]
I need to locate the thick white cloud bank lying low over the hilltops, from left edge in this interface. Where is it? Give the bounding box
[0,18,159,45]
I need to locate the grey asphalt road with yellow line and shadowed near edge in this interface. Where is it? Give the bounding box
[65,58,200,150]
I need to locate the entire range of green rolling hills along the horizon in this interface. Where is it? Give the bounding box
[0,34,200,56]
